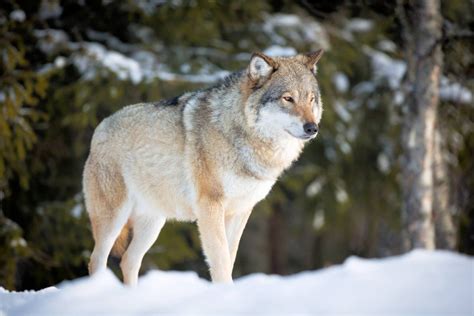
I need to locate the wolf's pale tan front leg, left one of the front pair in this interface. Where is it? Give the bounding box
[197,203,232,283]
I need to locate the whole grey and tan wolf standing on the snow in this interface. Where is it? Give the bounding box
[83,50,323,285]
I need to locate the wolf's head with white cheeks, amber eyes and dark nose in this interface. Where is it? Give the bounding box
[246,50,323,140]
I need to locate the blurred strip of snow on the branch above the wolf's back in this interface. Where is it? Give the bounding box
[34,29,230,84]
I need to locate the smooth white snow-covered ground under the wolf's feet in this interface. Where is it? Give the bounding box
[0,250,474,316]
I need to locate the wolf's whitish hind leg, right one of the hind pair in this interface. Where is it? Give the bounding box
[120,214,166,286]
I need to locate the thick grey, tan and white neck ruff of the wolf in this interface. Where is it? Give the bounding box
[194,71,304,180]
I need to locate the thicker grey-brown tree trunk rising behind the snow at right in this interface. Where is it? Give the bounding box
[398,0,442,249]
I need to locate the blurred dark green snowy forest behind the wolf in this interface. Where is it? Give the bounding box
[0,0,474,290]
